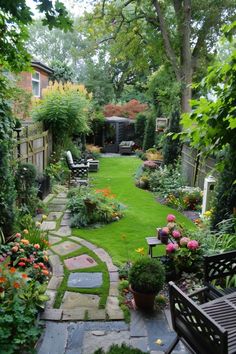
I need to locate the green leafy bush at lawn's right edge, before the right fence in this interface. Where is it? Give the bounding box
[149,165,184,197]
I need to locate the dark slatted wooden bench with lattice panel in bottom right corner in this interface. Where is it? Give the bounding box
[165,282,236,354]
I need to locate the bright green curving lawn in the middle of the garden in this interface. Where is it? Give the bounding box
[73,157,195,265]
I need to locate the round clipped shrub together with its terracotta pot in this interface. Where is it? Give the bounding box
[129,257,165,310]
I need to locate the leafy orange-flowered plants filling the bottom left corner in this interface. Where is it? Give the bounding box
[0,260,48,354]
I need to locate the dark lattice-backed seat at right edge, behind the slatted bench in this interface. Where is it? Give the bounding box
[204,251,236,299]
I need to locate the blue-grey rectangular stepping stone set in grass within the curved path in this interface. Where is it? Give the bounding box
[68,273,102,288]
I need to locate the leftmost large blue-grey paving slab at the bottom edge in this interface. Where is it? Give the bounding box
[38,322,67,354]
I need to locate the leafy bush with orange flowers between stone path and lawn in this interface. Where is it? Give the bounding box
[68,187,123,227]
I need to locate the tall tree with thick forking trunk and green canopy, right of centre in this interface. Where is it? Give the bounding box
[82,0,236,112]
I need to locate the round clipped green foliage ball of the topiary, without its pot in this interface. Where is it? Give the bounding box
[129,257,165,294]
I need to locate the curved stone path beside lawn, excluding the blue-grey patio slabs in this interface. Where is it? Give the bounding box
[41,190,124,321]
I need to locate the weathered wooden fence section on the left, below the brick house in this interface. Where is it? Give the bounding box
[14,123,50,173]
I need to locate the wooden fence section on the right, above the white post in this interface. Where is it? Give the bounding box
[182,145,216,189]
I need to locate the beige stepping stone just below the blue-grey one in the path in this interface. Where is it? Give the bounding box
[61,291,100,309]
